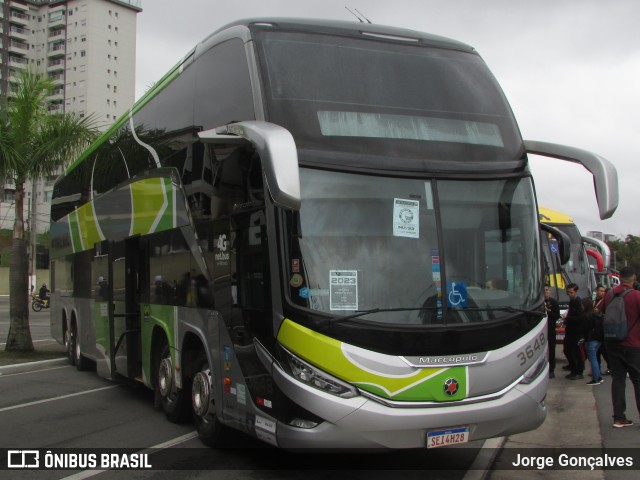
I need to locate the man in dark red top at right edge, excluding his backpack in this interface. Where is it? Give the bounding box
[600,267,640,428]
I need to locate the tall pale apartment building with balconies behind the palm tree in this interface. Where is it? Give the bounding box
[0,0,142,233]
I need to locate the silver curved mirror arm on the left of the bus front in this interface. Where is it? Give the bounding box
[198,120,301,211]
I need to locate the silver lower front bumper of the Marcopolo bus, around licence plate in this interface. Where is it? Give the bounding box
[274,368,549,450]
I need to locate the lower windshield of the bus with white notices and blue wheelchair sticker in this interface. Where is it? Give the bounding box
[288,168,542,325]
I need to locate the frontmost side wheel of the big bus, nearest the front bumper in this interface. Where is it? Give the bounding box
[191,352,224,447]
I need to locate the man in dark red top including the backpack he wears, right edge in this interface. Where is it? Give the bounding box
[600,267,640,428]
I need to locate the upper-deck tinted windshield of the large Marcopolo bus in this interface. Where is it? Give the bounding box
[252,31,522,168]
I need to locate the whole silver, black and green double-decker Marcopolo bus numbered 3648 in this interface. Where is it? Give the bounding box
[51,18,617,449]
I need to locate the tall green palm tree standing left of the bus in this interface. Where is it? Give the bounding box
[0,69,98,351]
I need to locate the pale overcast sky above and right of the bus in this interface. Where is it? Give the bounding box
[136,0,640,236]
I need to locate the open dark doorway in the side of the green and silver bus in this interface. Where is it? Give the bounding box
[109,237,149,378]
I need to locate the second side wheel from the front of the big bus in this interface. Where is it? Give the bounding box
[151,327,189,423]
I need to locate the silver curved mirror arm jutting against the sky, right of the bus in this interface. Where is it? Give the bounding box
[524,140,618,220]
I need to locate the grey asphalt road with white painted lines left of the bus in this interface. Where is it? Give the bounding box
[0,297,483,480]
